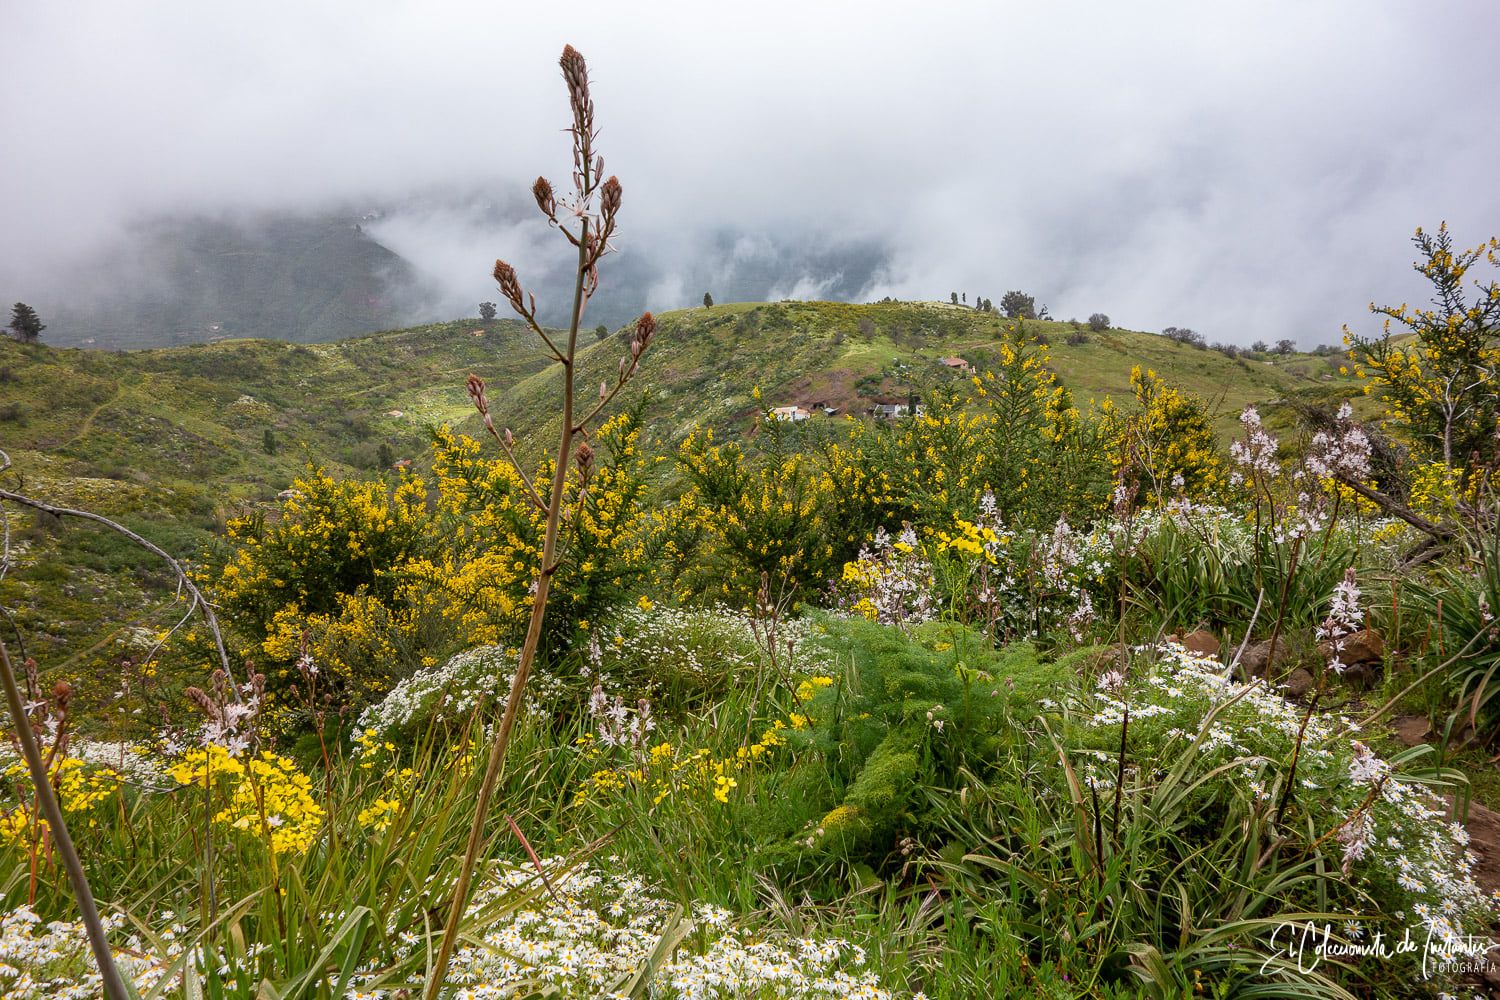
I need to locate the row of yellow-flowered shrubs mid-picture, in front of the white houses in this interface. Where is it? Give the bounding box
[677,327,1113,598]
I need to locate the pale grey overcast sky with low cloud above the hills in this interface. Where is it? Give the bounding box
[0,0,1500,346]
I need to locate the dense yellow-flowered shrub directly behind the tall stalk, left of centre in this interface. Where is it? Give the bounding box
[215,414,660,724]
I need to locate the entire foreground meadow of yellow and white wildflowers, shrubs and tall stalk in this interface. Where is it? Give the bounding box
[0,39,1500,1000]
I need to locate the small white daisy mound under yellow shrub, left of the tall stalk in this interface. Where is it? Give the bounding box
[354,646,563,738]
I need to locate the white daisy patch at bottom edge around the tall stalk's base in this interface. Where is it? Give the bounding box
[359,859,893,1000]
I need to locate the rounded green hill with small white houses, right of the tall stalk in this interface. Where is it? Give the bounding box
[497,301,1356,452]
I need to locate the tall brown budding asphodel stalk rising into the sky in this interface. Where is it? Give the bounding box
[426,45,656,1000]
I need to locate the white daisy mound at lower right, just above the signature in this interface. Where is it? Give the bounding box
[1070,642,1496,977]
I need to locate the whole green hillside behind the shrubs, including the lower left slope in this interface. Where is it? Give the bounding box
[0,303,1355,722]
